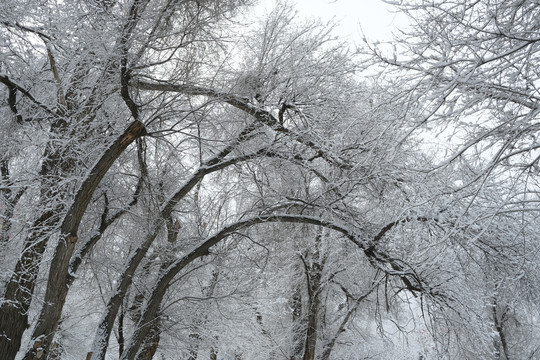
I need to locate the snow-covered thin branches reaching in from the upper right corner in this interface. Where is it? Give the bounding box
[371,1,540,178]
